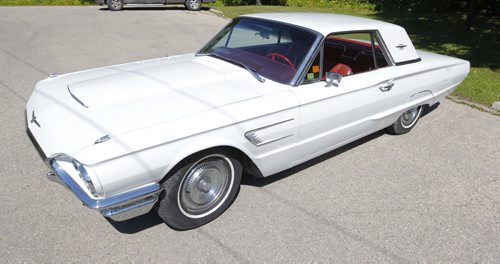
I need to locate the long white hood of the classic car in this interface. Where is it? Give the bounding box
[26,54,261,156]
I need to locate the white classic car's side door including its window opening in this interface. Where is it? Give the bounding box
[292,32,395,164]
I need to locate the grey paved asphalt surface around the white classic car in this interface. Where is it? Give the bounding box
[0,7,500,263]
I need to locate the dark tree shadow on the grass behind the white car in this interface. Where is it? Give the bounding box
[371,11,500,70]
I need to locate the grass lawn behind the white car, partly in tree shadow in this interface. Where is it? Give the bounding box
[206,3,500,105]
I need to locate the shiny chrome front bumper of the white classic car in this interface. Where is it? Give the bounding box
[47,160,162,221]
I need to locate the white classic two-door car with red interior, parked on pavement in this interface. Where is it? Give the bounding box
[26,13,469,230]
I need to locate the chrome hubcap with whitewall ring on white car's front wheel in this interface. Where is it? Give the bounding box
[179,155,234,217]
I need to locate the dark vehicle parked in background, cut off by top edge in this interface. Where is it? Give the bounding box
[95,0,215,11]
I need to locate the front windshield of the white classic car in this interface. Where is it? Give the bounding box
[198,18,317,84]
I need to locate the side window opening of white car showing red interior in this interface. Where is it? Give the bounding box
[323,32,388,76]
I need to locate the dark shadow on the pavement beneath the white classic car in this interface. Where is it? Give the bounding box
[106,103,440,234]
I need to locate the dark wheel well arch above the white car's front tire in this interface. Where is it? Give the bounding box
[160,146,263,183]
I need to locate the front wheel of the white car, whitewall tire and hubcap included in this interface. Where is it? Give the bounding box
[157,152,242,230]
